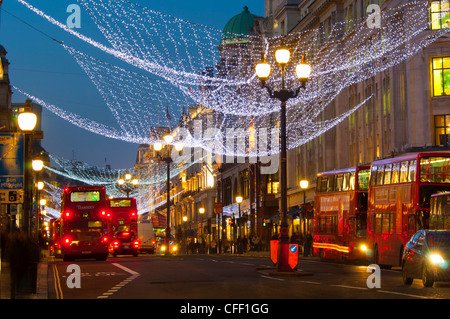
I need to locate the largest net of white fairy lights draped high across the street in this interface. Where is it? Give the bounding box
[14,0,448,156]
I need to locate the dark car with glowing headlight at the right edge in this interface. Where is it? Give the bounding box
[402,230,450,287]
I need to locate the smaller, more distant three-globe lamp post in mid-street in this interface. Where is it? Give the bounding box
[153,134,183,256]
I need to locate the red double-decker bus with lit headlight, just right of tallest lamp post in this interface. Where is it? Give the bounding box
[313,165,370,260]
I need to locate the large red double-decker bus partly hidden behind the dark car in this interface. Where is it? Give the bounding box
[367,152,450,267]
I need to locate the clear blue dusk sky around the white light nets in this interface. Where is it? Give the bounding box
[0,0,264,169]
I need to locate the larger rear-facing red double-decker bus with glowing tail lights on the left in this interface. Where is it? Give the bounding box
[61,186,108,261]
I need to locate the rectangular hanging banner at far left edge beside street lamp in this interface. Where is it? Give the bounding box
[0,133,25,203]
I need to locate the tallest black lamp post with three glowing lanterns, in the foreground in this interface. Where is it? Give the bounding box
[255,47,311,272]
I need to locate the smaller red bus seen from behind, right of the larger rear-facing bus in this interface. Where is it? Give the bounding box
[108,197,138,237]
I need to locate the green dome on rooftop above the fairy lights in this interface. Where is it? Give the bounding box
[222,6,257,43]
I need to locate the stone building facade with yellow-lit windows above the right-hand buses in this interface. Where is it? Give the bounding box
[259,0,450,240]
